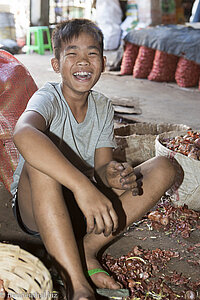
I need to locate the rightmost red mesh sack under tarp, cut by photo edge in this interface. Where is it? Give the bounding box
[175,57,200,87]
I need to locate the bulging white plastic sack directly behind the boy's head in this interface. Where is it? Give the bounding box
[96,0,122,50]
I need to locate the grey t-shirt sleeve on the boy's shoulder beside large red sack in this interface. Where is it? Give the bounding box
[25,90,54,126]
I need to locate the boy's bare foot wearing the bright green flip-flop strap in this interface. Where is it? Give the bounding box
[86,255,122,290]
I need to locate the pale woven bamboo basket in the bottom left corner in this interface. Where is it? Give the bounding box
[0,243,53,299]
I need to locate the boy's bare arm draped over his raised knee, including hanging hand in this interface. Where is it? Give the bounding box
[14,111,118,235]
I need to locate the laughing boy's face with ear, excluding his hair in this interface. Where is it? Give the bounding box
[52,33,105,96]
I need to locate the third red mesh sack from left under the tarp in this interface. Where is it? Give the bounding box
[148,50,178,82]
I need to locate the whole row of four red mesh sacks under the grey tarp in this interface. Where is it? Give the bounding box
[120,42,200,89]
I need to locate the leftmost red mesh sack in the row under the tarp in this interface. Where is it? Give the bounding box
[120,42,139,75]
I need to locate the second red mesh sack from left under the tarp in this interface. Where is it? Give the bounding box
[133,46,155,78]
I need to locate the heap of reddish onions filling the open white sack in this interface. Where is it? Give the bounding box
[161,131,200,160]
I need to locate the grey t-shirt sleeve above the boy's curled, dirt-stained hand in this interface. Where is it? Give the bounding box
[96,101,117,148]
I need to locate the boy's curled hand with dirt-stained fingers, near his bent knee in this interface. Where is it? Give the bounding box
[106,161,138,196]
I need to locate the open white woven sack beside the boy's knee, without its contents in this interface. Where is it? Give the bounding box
[155,131,200,211]
